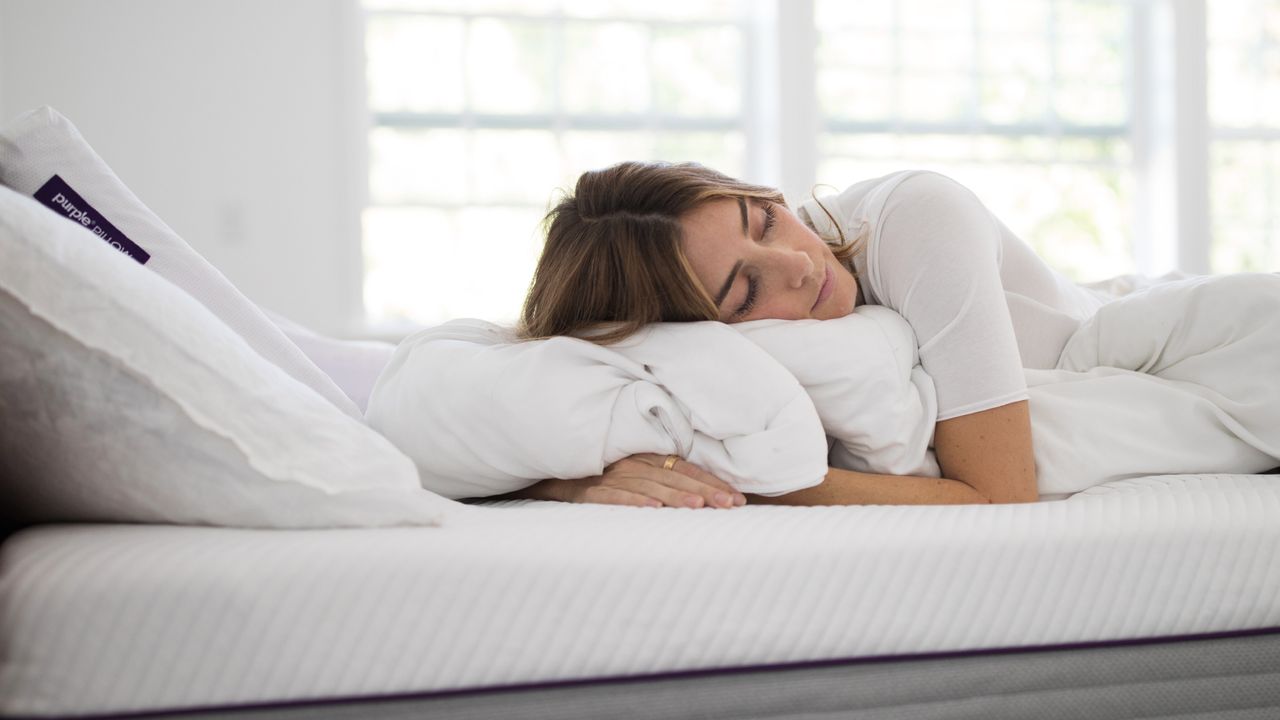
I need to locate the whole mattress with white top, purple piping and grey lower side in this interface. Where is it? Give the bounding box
[0,475,1280,719]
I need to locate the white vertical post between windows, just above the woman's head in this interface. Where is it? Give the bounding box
[773,0,822,202]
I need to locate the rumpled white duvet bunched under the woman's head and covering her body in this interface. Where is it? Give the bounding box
[367,274,1280,497]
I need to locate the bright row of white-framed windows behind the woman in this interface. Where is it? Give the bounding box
[362,0,1280,327]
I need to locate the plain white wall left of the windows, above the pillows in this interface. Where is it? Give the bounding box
[0,0,366,333]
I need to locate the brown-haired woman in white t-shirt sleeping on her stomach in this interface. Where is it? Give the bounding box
[504,163,1280,507]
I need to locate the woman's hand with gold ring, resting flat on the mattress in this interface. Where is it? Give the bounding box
[513,454,746,507]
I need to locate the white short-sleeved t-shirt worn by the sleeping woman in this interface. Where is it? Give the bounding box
[799,170,1108,420]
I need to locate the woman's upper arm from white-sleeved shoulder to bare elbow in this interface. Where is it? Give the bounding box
[849,173,1038,502]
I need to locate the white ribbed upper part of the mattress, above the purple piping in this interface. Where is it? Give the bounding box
[0,475,1280,715]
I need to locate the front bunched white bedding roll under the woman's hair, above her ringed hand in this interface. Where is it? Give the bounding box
[365,318,829,498]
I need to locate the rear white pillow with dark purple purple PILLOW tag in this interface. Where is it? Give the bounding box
[0,106,361,418]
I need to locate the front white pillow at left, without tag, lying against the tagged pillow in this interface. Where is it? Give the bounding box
[0,187,457,528]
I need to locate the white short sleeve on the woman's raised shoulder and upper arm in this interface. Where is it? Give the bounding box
[863,173,1027,420]
